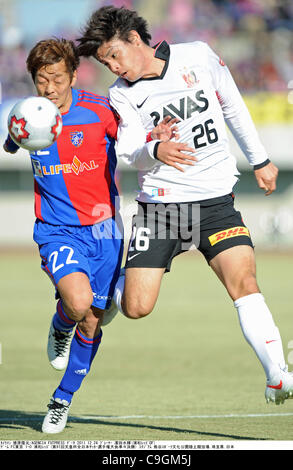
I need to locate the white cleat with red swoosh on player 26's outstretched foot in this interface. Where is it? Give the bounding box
[265,370,293,405]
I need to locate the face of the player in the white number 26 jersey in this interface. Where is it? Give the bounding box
[96,36,149,82]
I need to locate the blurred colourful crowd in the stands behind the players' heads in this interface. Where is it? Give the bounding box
[0,0,293,99]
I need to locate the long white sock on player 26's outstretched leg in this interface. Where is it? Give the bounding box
[234,293,286,379]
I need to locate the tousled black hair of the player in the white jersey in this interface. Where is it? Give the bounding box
[77,6,151,57]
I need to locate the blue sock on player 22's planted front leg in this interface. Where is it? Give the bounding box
[53,328,103,403]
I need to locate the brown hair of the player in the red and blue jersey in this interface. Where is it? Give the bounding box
[26,37,80,81]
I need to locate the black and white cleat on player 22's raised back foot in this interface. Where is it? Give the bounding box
[47,320,73,370]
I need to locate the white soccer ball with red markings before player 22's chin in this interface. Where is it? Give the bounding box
[8,96,62,151]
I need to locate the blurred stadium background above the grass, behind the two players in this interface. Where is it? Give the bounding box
[0,0,293,246]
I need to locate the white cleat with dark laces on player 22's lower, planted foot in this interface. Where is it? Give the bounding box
[42,398,71,434]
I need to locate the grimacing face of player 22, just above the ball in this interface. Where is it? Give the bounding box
[35,59,76,113]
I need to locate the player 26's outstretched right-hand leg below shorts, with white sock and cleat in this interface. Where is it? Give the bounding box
[210,242,293,403]
